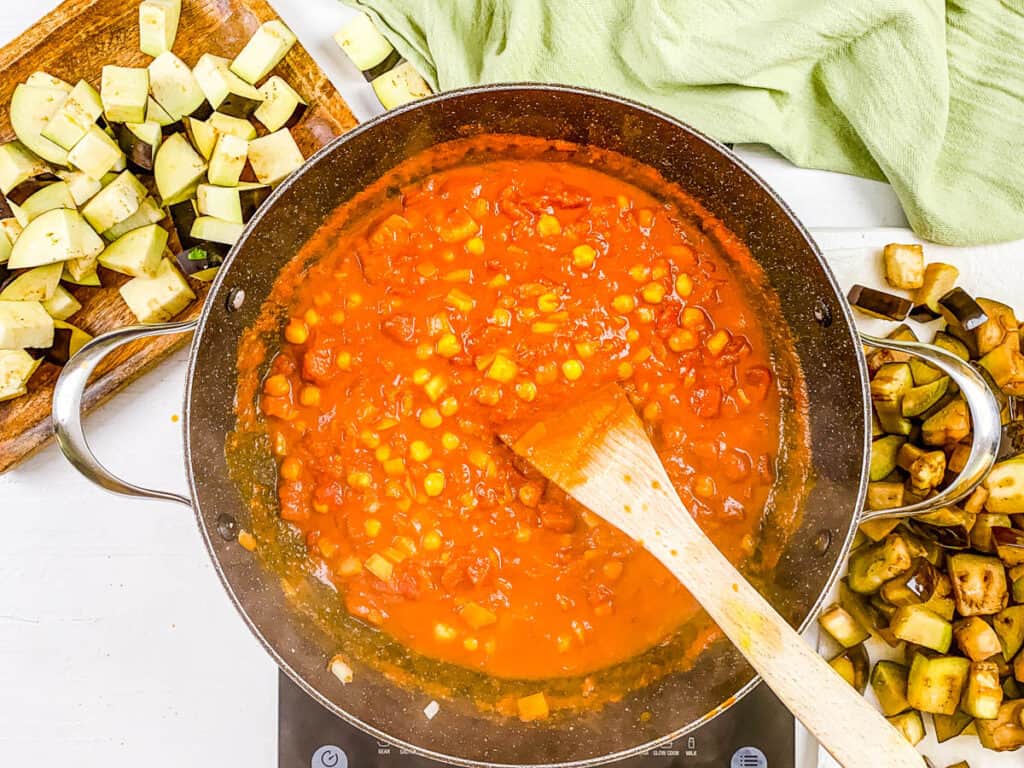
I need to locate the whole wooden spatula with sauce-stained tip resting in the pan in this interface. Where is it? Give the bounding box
[502,385,925,768]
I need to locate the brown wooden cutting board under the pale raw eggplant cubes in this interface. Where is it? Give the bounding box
[0,0,356,472]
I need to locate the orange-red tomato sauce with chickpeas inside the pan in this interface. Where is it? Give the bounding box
[251,154,782,679]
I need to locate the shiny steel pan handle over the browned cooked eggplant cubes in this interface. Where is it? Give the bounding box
[860,333,1002,522]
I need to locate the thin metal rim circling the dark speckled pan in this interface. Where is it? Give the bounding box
[182,82,870,768]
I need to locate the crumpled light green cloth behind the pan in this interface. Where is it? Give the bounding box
[346,0,1024,245]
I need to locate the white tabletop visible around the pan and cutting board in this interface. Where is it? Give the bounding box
[0,0,1024,768]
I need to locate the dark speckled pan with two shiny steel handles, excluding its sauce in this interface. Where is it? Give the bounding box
[53,85,998,766]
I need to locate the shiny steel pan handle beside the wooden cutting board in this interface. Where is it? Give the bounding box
[53,319,198,507]
